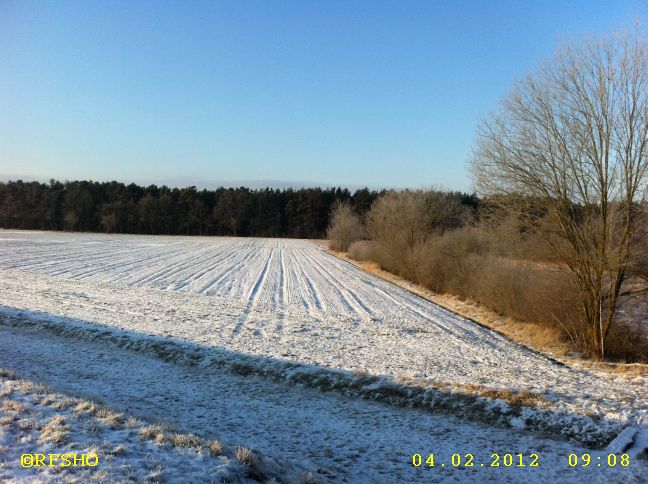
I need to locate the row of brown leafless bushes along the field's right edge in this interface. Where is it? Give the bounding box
[340,185,648,361]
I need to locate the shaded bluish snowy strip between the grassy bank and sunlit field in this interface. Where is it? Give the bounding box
[0,326,648,483]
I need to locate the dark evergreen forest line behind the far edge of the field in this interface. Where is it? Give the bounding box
[0,180,381,238]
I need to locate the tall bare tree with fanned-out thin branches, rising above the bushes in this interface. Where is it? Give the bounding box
[471,30,648,357]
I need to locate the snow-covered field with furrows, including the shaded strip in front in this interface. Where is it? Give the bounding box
[0,231,648,482]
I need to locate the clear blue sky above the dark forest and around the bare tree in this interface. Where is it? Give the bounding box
[0,0,648,190]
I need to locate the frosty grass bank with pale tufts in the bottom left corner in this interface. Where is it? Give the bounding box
[0,370,310,482]
